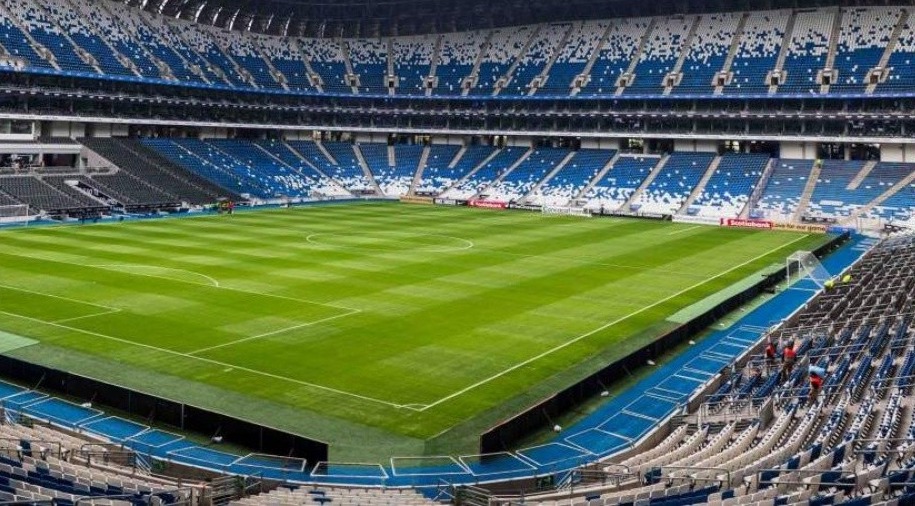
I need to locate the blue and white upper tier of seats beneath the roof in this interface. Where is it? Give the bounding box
[0,0,915,97]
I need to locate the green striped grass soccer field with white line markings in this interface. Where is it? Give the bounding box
[0,203,825,460]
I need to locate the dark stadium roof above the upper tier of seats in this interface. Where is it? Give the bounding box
[131,0,880,37]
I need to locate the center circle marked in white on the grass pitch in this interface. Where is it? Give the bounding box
[305,232,473,253]
